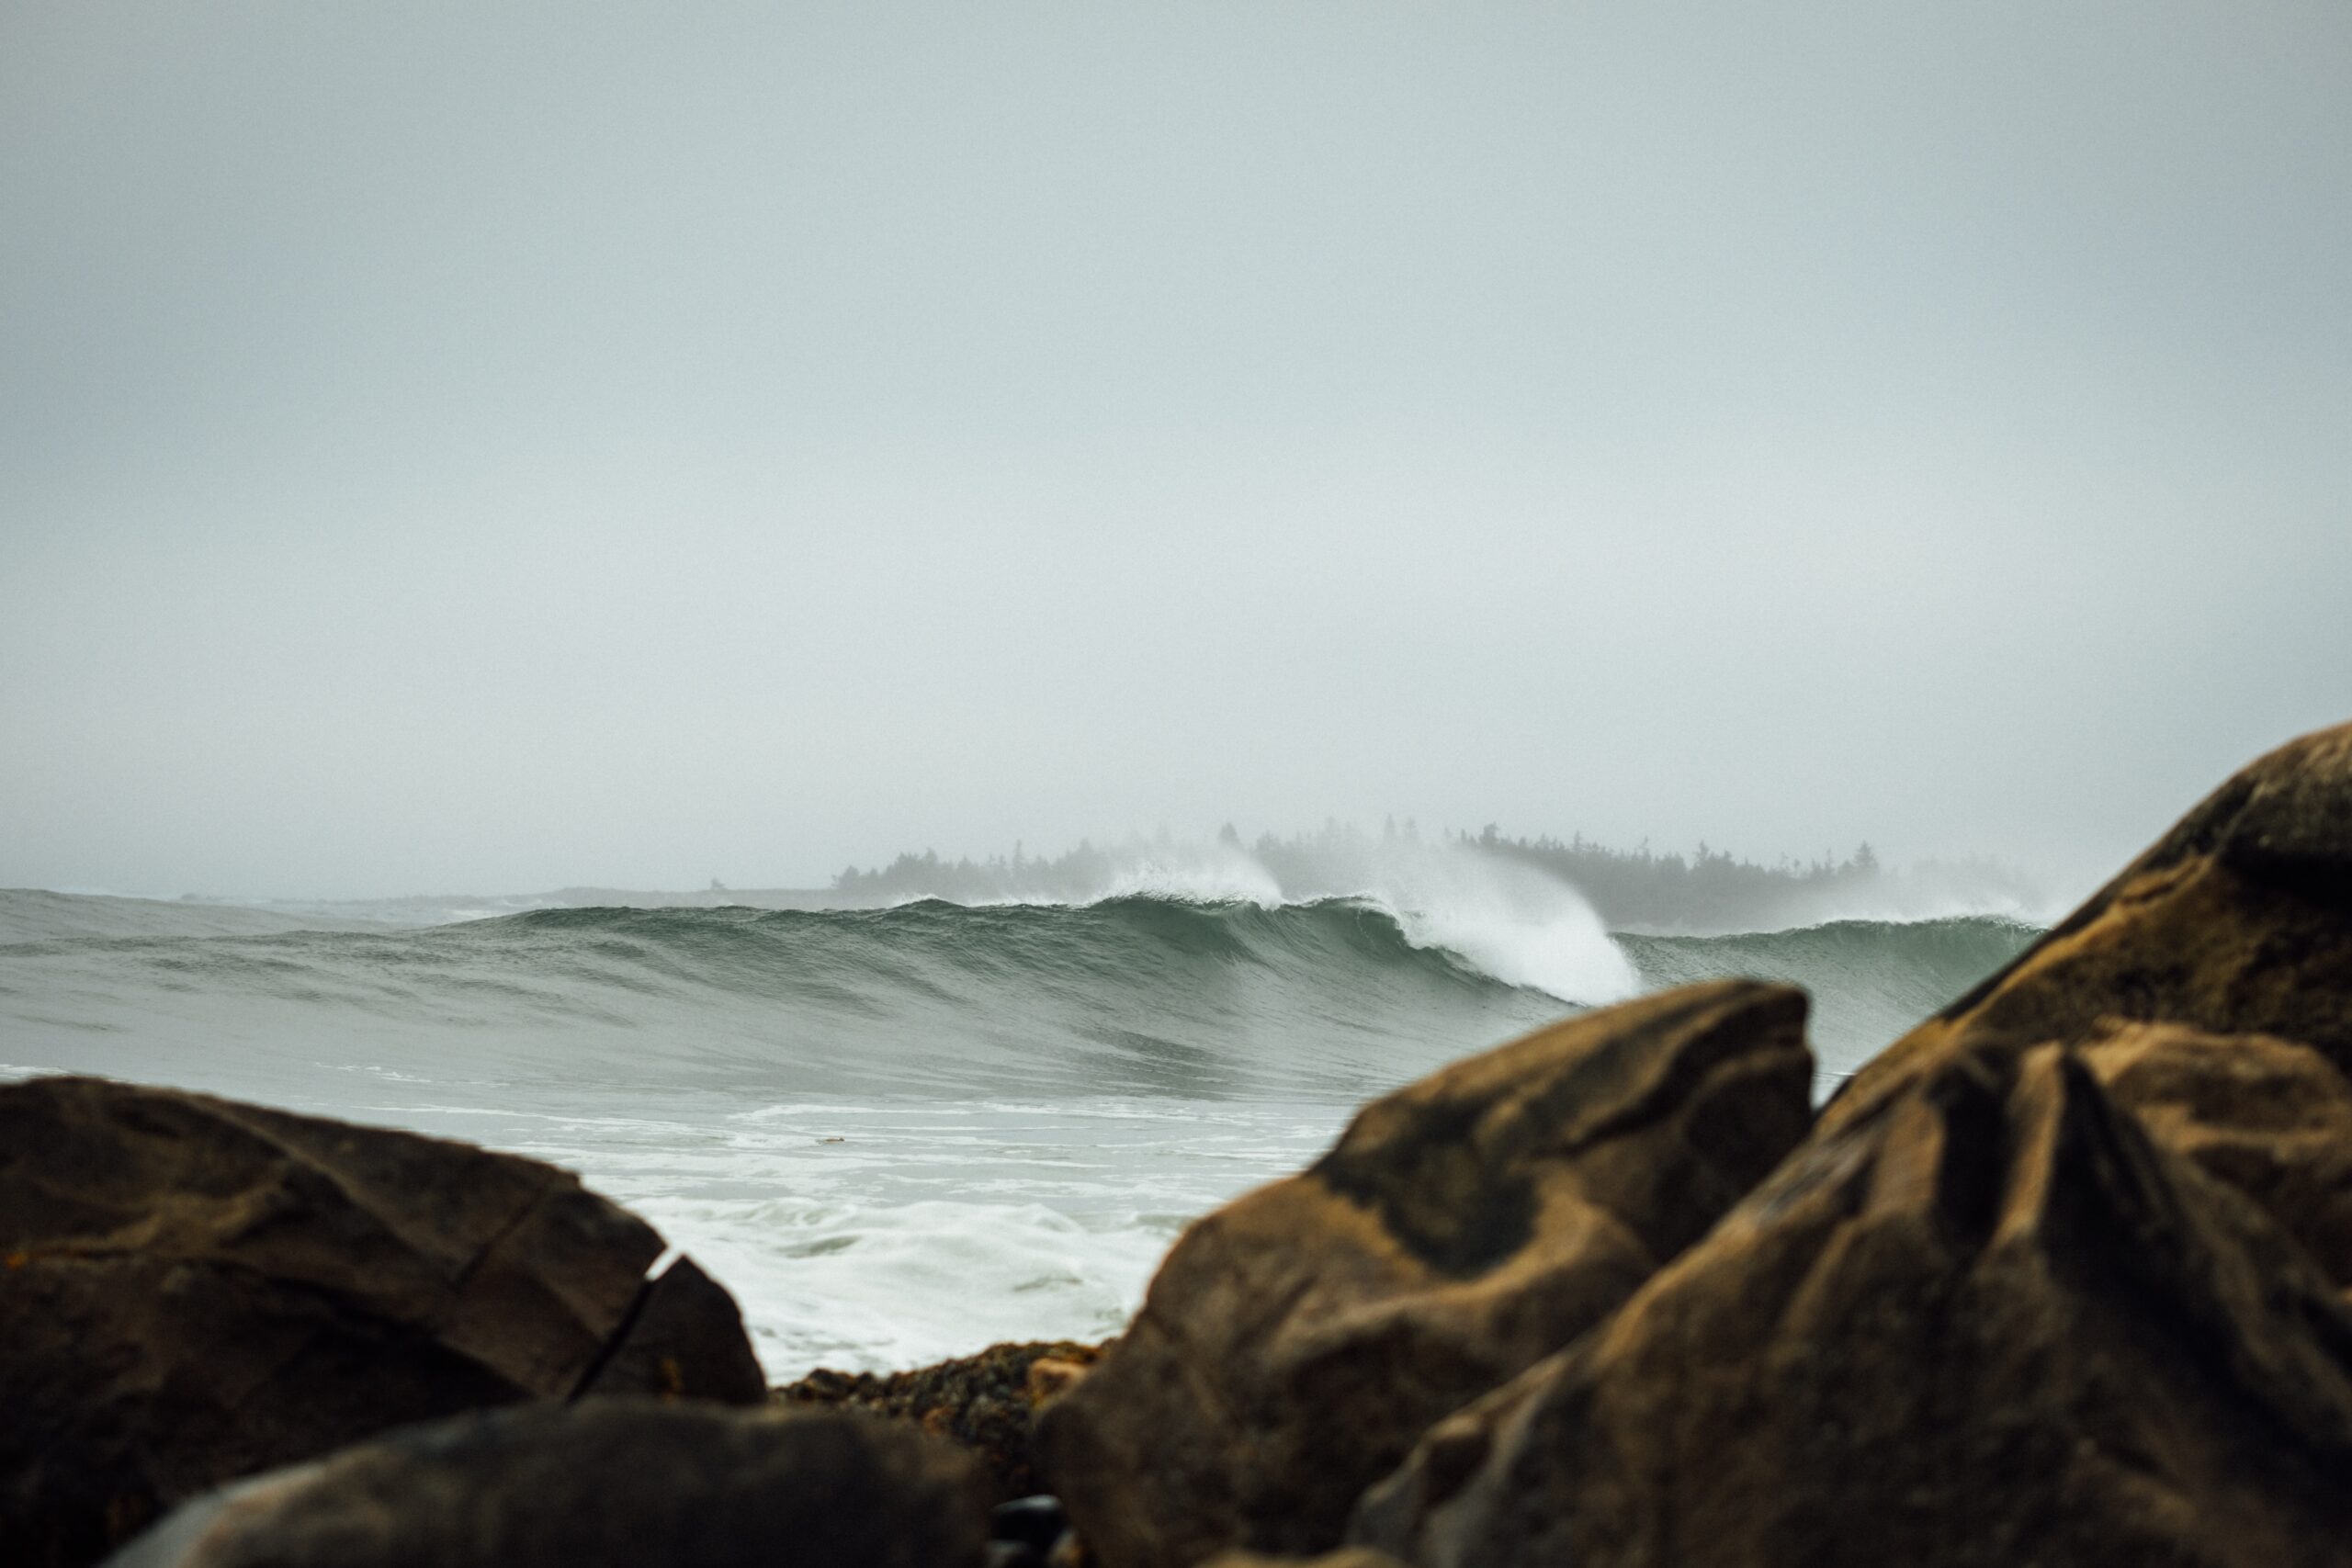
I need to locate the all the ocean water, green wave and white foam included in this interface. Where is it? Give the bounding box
[0,888,2037,1380]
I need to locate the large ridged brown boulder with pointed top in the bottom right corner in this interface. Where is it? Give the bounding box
[1355,1046,2352,1568]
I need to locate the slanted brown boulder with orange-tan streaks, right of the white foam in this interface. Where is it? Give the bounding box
[1037,980,1814,1568]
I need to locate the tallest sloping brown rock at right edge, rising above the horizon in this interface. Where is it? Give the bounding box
[1823,724,2352,1126]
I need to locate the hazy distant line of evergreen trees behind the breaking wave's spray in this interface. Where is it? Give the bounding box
[832,820,2037,931]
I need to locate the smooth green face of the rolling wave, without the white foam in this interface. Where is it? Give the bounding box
[0,898,2034,1100]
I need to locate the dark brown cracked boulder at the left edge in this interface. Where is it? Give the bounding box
[0,1079,764,1568]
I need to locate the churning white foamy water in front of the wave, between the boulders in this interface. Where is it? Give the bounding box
[501,1100,1343,1378]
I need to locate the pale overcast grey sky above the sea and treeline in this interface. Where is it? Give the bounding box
[0,0,2352,896]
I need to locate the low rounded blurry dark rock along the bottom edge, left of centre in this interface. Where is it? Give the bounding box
[110,1399,986,1568]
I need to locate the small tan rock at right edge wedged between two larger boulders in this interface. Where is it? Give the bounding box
[2082,1022,2352,1291]
